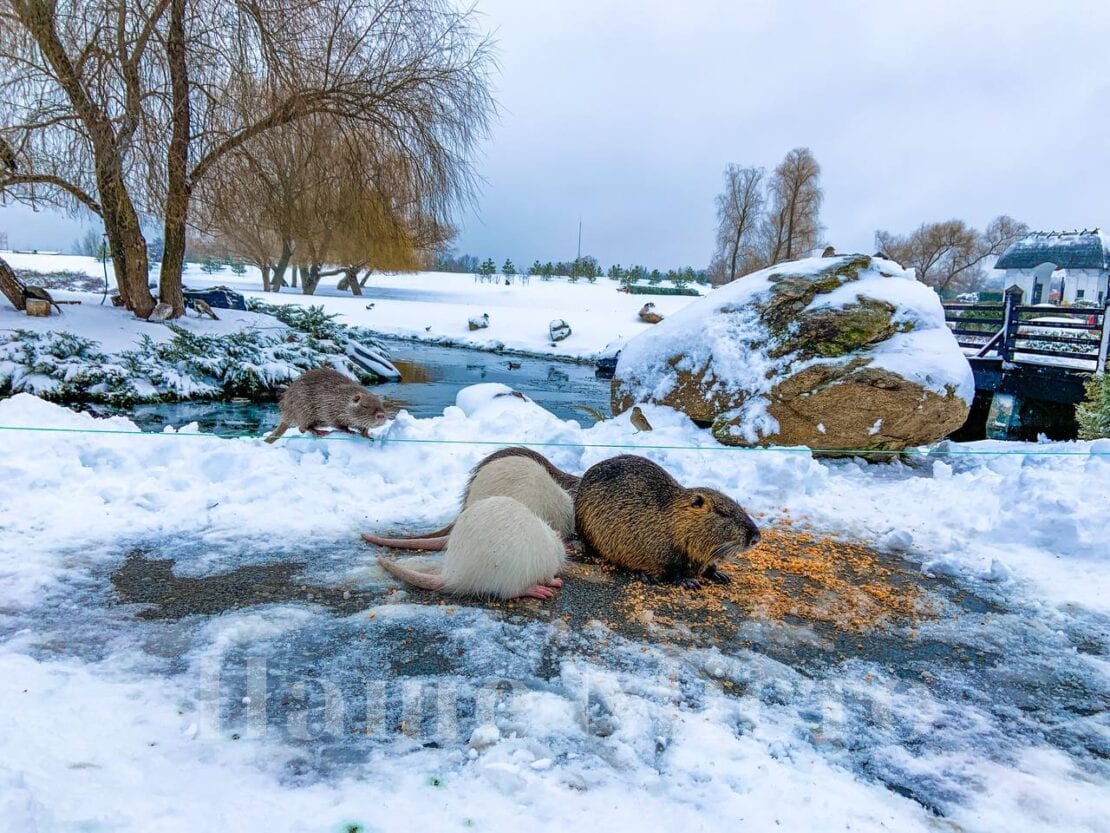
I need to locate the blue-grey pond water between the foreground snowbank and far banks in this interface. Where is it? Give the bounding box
[89,340,609,434]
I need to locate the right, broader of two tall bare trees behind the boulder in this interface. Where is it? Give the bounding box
[763,148,825,265]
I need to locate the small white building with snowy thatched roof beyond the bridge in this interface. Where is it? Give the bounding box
[995,229,1110,307]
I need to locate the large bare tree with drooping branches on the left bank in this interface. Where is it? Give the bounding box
[0,0,493,317]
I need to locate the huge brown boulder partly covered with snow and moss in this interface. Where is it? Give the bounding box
[613,254,975,451]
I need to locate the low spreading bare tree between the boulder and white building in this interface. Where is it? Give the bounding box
[875,214,1028,292]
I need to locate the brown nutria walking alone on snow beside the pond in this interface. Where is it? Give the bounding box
[266,368,387,442]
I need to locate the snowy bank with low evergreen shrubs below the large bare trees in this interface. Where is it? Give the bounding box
[0,255,396,404]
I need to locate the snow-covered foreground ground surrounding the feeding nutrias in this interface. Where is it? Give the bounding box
[0,390,1110,833]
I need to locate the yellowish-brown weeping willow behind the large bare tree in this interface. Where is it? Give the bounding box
[196,118,453,294]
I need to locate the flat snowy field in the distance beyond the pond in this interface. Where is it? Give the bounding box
[0,252,706,359]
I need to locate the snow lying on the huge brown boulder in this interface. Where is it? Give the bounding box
[617,258,975,442]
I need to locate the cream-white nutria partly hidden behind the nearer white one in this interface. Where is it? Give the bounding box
[362,456,574,550]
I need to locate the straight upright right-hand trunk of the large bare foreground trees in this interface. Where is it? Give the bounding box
[158,0,190,318]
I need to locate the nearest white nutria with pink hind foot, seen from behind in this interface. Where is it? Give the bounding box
[377,496,564,599]
